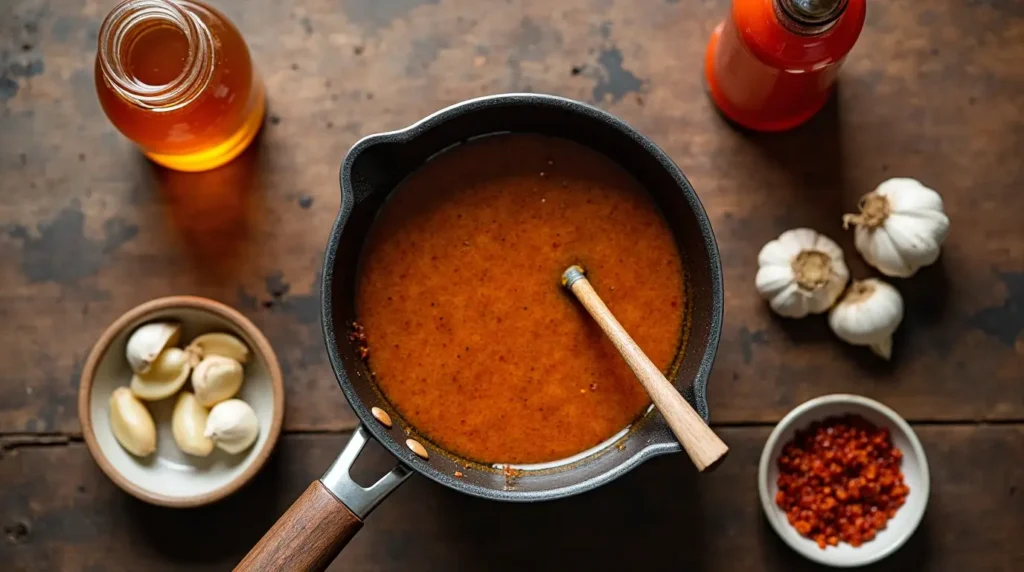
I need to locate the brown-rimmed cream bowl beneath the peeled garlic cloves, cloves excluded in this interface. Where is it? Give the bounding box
[78,296,285,508]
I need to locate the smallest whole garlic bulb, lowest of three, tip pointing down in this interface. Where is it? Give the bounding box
[828,278,903,359]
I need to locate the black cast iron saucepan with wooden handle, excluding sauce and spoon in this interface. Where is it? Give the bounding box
[239,94,723,571]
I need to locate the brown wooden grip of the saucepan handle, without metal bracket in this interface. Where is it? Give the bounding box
[234,481,362,572]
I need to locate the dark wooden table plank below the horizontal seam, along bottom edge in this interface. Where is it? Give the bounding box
[0,425,1024,572]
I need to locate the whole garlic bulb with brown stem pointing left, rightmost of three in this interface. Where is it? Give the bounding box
[843,178,949,278]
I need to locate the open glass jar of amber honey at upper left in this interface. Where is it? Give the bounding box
[95,0,265,171]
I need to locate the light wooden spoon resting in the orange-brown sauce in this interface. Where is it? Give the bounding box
[562,265,729,471]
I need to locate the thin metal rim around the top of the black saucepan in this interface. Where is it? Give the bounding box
[321,93,724,501]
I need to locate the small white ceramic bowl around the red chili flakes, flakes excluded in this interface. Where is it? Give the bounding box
[758,394,930,568]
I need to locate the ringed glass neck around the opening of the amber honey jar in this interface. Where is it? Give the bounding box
[96,0,214,112]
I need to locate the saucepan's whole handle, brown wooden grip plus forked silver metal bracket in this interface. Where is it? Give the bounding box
[234,427,411,572]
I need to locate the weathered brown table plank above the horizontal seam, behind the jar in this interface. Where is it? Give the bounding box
[0,0,1024,433]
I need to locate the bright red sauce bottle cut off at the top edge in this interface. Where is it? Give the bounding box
[705,0,866,131]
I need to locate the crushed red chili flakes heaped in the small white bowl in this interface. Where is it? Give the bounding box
[775,415,910,548]
